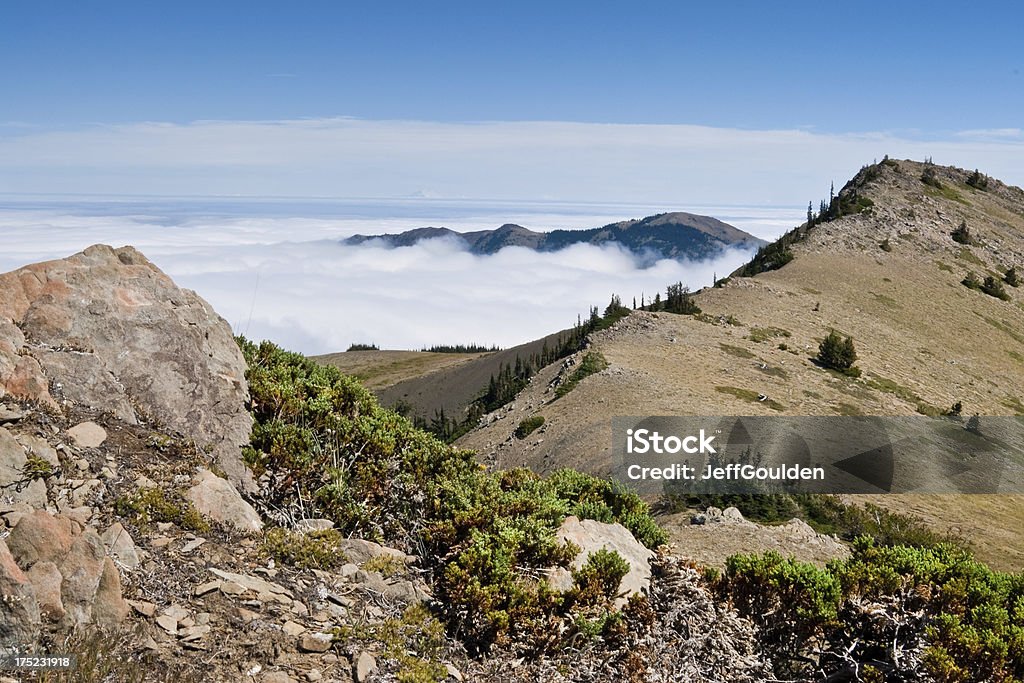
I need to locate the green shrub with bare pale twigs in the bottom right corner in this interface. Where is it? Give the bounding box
[718,538,1024,681]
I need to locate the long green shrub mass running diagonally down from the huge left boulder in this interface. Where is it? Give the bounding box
[239,339,666,652]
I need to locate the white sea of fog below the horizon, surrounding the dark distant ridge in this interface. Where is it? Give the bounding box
[0,197,803,353]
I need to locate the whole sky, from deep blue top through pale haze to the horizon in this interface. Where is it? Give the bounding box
[0,1,1024,204]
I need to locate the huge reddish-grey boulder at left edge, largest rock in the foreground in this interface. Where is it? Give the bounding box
[0,245,255,490]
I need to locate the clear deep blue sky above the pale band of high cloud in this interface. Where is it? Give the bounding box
[0,0,1024,137]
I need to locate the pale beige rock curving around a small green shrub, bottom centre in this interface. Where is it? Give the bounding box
[556,516,654,607]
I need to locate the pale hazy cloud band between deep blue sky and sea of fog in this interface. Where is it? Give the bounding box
[0,118,1024,205]
